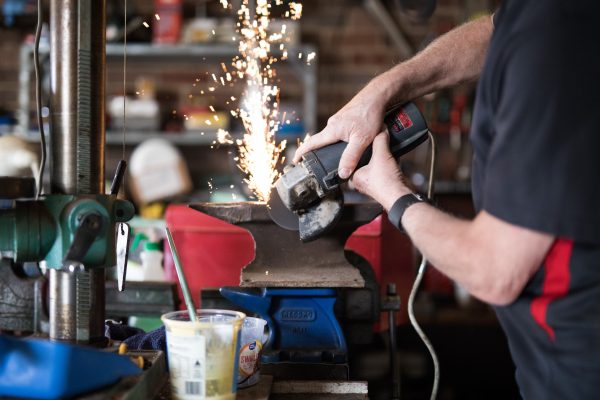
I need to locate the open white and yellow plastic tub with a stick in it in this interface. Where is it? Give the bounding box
[161,309,246,400]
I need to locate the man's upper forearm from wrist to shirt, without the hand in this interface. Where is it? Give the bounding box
[370,16,493,105]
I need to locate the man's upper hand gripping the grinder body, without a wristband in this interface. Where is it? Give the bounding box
[293,81,386,179]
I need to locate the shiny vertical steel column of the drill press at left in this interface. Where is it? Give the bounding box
[49,0,106,342]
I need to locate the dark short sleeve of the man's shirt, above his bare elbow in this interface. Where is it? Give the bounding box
[482,14,600,243]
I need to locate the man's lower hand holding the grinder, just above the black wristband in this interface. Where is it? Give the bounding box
[352,131,411,211]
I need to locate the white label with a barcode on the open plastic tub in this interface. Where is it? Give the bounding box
[167,329,206,399]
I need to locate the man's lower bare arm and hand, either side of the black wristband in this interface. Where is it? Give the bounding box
[353,133,554,305]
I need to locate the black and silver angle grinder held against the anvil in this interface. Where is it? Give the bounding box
[269,103,429,242]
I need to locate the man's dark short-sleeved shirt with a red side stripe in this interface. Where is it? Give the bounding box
[471,0,600,399]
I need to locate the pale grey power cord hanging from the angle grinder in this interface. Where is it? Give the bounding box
[407,131,440,400]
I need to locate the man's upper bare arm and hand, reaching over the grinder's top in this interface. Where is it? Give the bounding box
[294,16,493,179]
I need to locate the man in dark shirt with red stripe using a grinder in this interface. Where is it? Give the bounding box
[295,0,600,399]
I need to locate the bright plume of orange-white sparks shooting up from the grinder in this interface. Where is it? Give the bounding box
[200,0,302,202]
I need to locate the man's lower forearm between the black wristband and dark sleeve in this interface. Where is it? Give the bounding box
[402,204,554,305]
